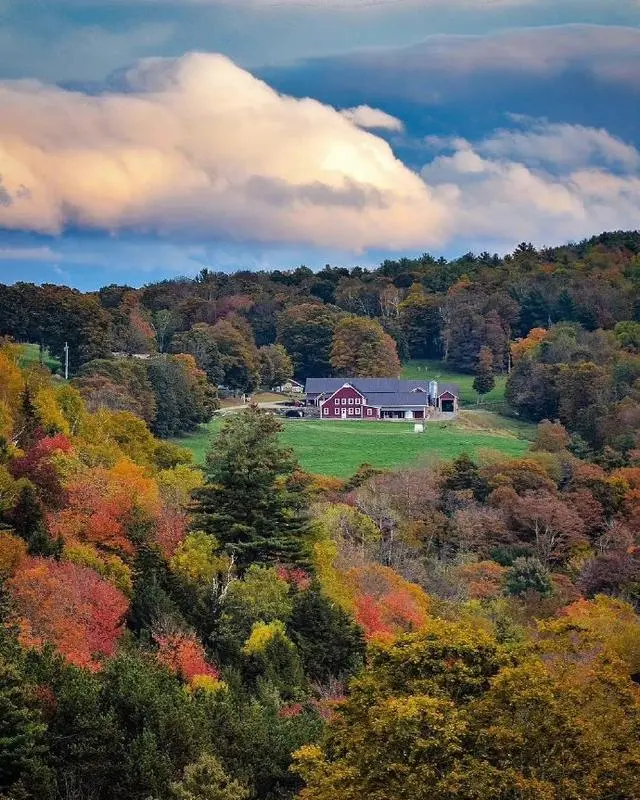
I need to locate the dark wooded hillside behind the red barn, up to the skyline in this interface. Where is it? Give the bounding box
[0,232,640,464]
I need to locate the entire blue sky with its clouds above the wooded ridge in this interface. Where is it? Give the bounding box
[0,0,640,290]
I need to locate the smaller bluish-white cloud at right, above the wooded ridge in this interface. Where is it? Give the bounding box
[422,121,640,246]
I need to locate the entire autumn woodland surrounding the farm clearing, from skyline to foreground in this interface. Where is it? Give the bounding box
[0,228,640,800]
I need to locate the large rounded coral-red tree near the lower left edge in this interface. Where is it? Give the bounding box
[7,558,128,671]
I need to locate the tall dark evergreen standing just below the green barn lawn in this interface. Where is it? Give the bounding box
[194,407,306,570]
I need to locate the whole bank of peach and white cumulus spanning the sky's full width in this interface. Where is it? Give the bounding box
[0,54,640,260]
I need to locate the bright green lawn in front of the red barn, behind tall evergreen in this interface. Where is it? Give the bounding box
[175,412,531,478]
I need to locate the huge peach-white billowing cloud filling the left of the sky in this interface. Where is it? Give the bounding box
[0,54,444,251]
